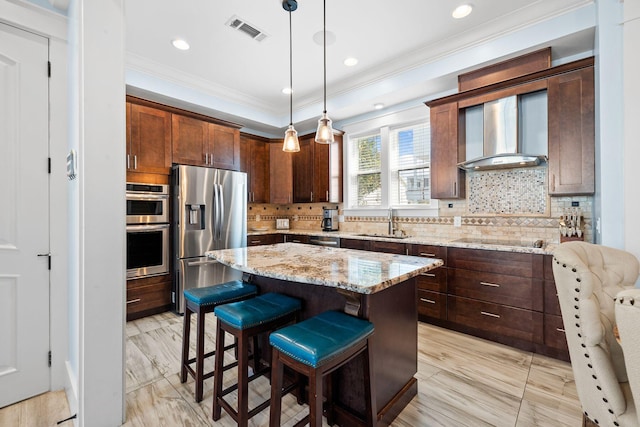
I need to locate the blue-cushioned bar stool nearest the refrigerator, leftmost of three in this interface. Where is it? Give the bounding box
[180,280,258,402]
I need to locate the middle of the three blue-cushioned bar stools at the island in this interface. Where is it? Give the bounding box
[213,293,302,427]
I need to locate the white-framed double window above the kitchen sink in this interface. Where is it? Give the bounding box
[345,118,431,209]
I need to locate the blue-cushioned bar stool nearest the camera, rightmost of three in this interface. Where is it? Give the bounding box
[269,311,377,427]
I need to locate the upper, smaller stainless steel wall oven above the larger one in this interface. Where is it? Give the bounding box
[126,182,169,224]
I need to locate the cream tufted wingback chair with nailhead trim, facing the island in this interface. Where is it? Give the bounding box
[553,242,640,427]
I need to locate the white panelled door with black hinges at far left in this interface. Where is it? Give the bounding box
[0,24,50,407]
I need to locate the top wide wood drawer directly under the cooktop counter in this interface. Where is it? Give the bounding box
[447,248,542,277]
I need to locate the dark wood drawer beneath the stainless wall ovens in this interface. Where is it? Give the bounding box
[127,274,171,321]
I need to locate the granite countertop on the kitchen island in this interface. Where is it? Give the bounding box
[206,243,443,294]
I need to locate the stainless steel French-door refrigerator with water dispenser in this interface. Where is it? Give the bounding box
[171,165,247,313]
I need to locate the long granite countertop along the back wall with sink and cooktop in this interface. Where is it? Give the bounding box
[247,228,557,254]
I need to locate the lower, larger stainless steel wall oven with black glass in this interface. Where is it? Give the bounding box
[127,224,169,279]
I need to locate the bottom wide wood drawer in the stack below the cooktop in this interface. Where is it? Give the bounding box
[447,295,543,344]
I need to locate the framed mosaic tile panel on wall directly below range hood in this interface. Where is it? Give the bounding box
[467,168,547,215]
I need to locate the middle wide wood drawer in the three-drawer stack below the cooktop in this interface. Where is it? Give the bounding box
[447,268,542,311]
